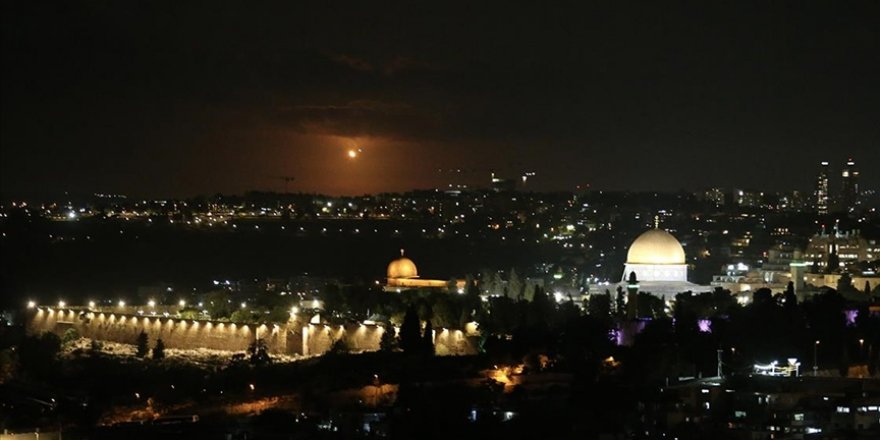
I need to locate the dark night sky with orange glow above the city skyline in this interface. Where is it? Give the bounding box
[0,0,880,196]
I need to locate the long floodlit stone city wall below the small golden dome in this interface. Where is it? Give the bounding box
[27,307,477,356]
